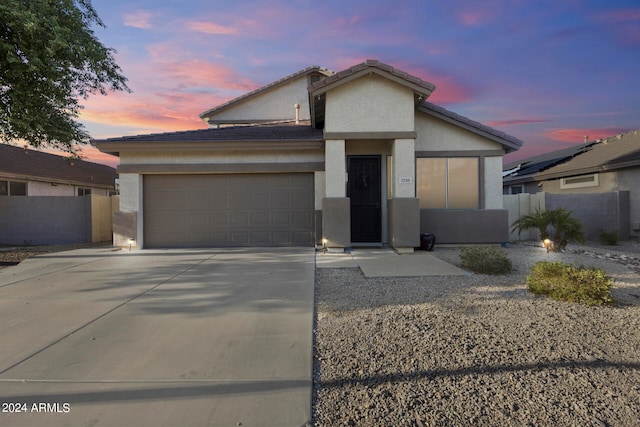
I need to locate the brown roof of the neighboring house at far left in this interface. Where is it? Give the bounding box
[0,144,118,188]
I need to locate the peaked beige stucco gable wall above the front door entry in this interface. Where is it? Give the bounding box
[325,74,414,132]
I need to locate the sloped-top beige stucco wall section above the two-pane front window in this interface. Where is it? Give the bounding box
[415,111,503,152]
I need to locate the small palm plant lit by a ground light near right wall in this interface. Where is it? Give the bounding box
[511,208,585,252]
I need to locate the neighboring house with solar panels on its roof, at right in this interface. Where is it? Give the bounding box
[504,129,640,241]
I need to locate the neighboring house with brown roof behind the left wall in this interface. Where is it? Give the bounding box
[0,144,118,196]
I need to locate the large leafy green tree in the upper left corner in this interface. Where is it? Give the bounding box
[0,0,129,153]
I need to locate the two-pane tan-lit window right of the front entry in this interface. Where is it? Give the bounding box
[416,157,480,209]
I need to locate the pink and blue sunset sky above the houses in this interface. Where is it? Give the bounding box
[76,0,640,169]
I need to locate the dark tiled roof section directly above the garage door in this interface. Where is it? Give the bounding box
[92,121,323,155]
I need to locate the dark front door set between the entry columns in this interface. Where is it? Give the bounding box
[347,156,382,243]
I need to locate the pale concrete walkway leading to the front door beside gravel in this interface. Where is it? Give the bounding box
[316,249,468,277]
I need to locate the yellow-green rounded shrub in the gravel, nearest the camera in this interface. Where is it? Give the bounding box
[527,261,613,305]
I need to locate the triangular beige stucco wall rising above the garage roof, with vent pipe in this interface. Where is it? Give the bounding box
[205,76,310,123]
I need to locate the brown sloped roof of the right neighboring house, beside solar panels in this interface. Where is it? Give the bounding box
[536,129,640,180]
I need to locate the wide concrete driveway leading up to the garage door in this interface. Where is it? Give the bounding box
[0,248,315,426]
